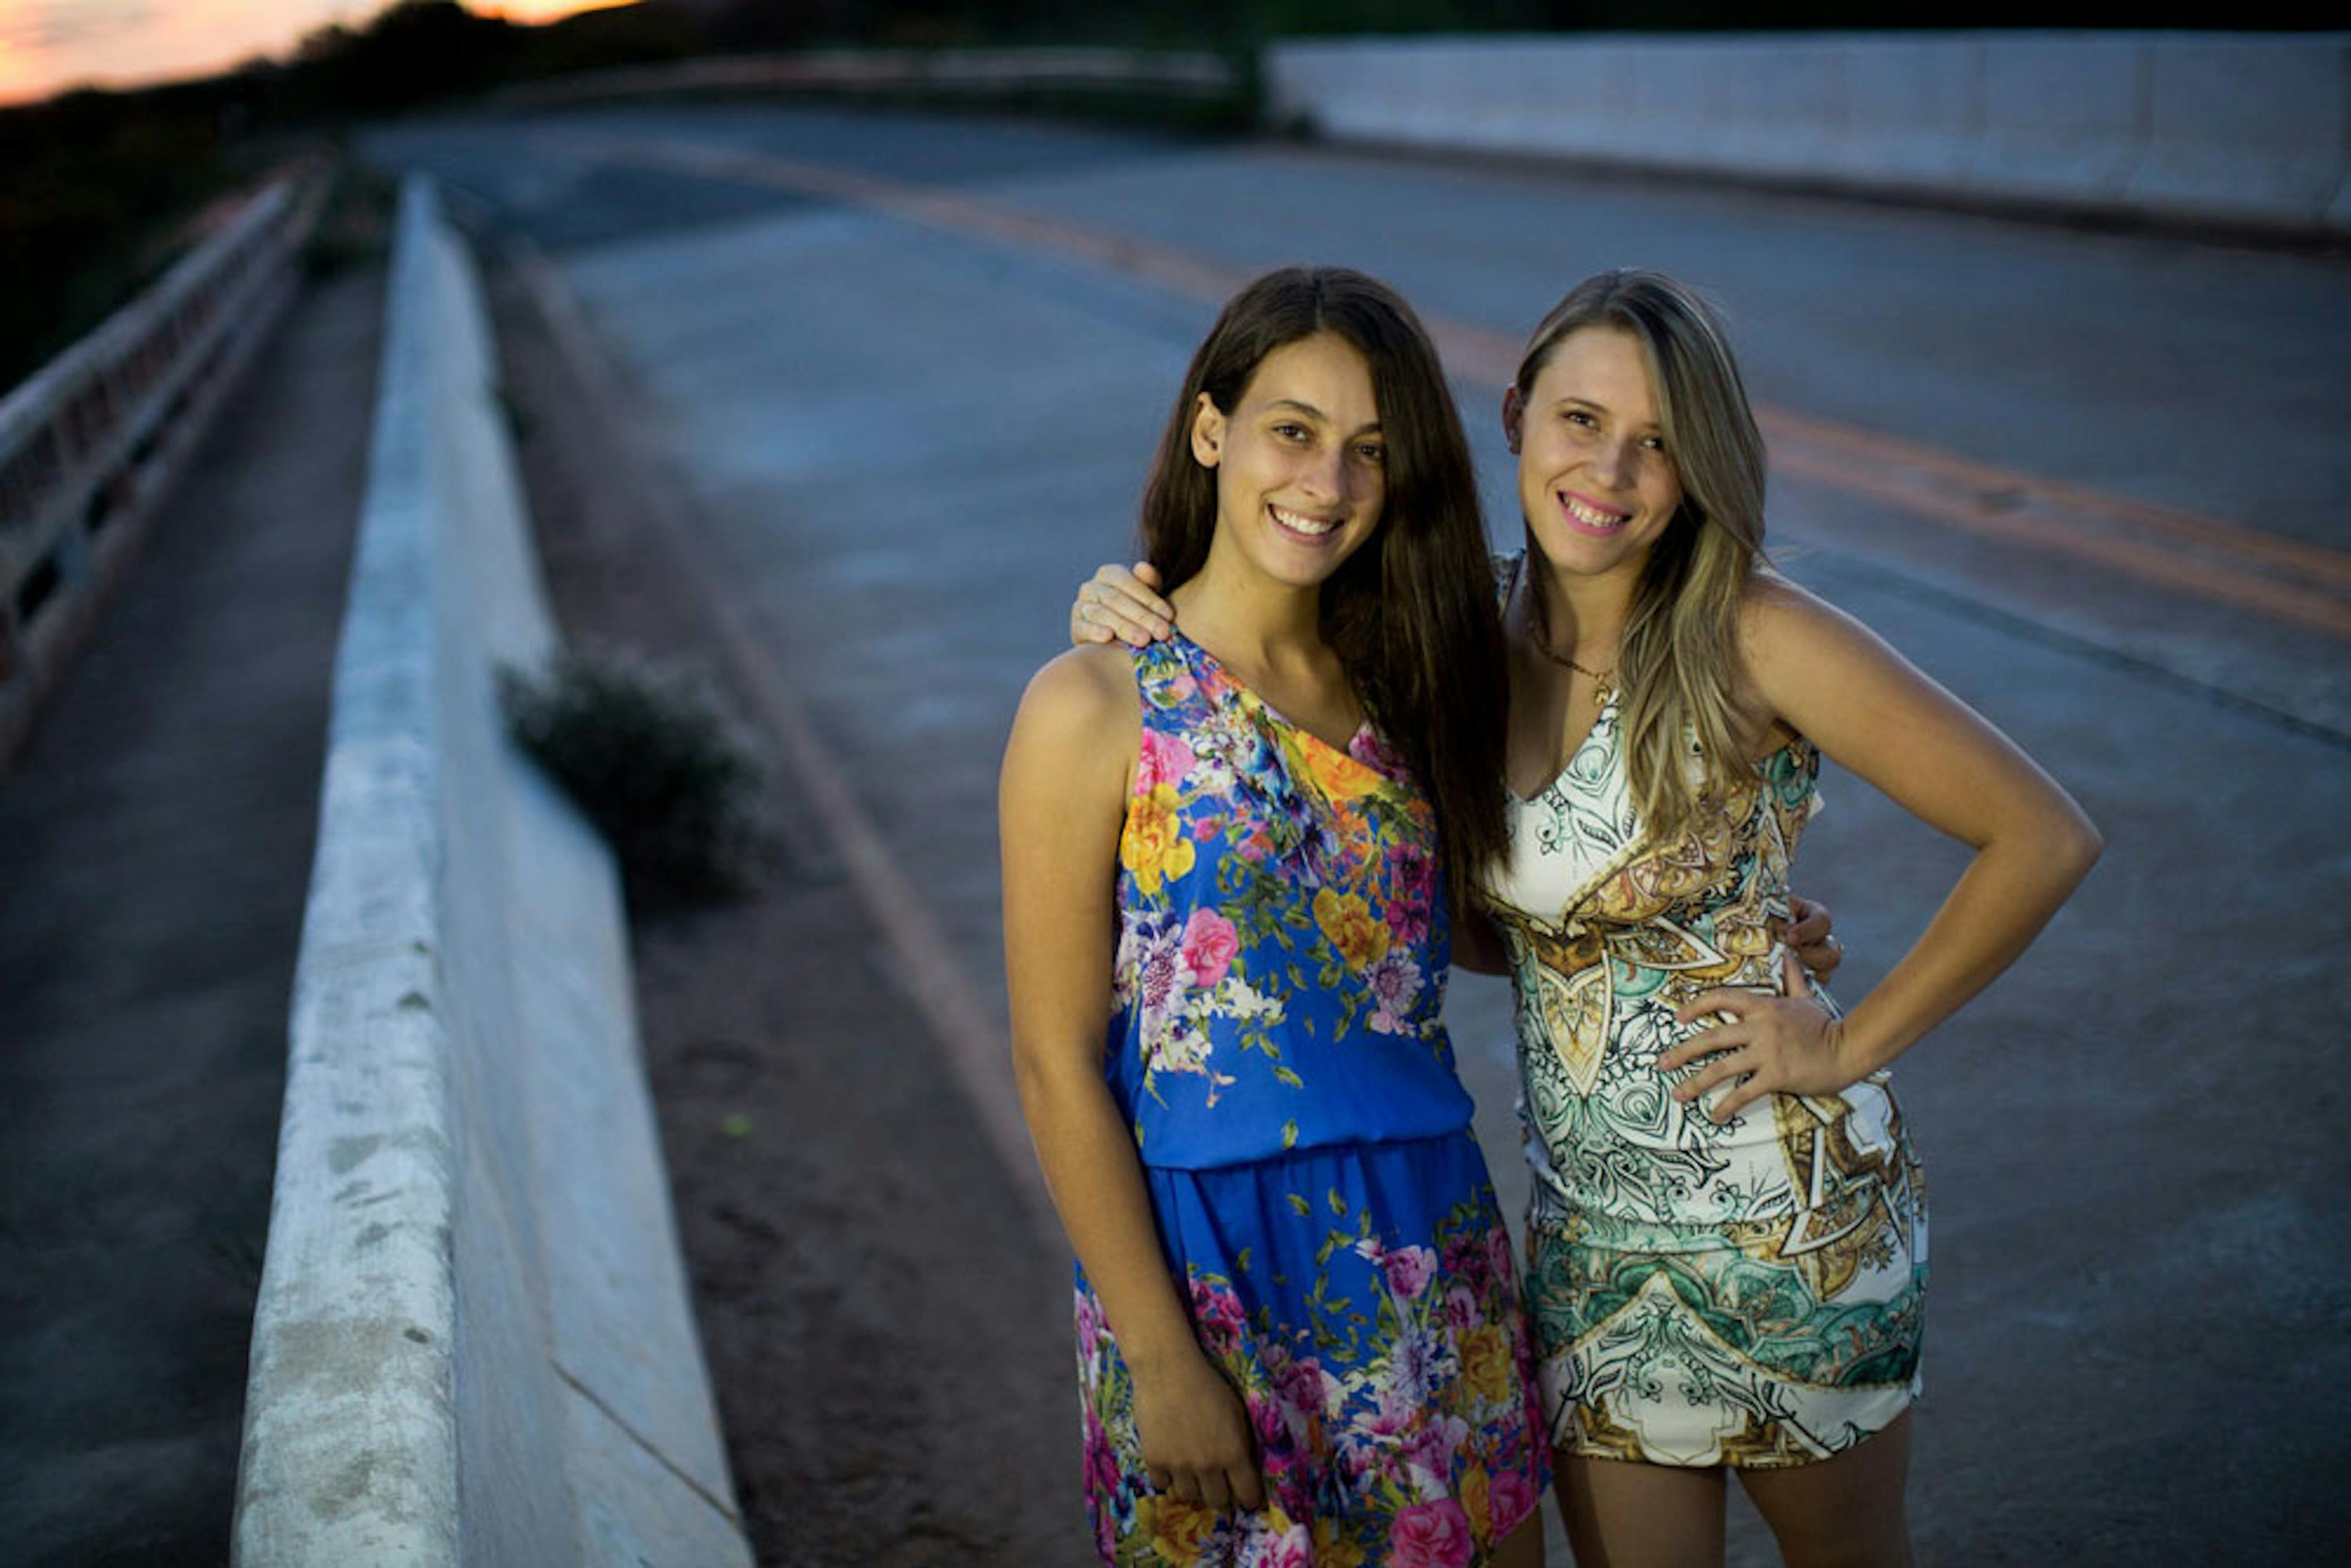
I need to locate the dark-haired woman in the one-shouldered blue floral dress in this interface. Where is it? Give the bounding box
[1002,268,1547,1568]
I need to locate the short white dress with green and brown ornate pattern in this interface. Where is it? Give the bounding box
[1491,677,1925,1467]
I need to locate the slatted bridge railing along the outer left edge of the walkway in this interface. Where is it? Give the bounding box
[0,174,324,764]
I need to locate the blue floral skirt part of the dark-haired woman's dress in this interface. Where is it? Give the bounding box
[1077,1138,1542,1568]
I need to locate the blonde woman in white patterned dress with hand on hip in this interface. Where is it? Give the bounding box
[1081,270,2099,1568]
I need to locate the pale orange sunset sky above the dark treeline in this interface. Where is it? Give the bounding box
[0,0,623,103]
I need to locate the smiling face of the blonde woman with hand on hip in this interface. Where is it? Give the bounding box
[1502,327,1681,578]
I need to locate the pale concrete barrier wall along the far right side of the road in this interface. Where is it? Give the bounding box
[1265,33,2351,233]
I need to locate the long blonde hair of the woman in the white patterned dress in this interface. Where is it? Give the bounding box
[1519,268,1768,837]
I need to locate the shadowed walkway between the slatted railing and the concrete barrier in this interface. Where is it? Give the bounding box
[0,268,383,1568]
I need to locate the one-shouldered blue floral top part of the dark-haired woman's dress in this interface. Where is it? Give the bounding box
[1107,635,1469,1166]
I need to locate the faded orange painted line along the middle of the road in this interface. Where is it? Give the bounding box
[534,132,2351,639]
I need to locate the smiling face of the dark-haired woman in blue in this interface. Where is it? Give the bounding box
[1192,331,1387,588]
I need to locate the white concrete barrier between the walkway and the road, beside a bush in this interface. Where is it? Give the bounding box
[235,181,750,1568]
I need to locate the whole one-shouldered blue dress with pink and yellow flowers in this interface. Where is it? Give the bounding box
[1077,632,1547,1568]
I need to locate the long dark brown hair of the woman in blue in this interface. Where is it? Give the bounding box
[1143,266,1509,907]
